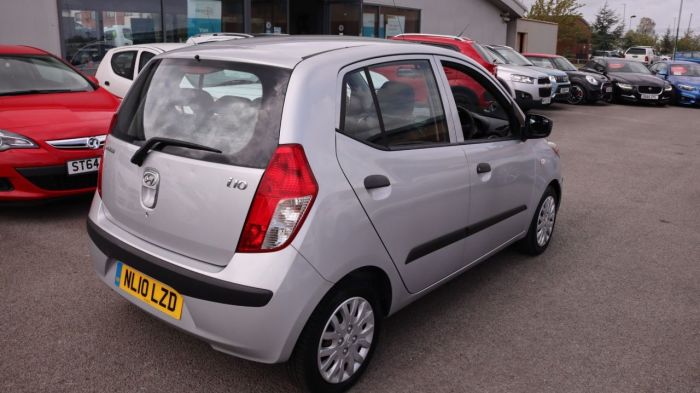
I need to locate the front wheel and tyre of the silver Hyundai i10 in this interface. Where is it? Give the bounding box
[519,186,559,255]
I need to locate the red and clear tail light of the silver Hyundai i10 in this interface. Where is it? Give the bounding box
[236,145,318,252]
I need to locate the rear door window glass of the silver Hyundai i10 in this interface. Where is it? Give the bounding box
[342,60,450,149]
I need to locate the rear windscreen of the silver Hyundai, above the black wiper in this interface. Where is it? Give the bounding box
[112,59,291,168]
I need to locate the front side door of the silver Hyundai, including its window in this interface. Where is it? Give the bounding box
[440,58,536,263]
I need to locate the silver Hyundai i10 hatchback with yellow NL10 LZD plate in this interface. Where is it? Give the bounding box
[88,37,562,392]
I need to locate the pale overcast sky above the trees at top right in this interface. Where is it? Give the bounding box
[523,0,700,34]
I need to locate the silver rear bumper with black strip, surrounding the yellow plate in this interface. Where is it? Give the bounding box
[88,195,332,363]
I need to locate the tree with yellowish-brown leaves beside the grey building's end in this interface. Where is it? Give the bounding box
[527,0,590,57]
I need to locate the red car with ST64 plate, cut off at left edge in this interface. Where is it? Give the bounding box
[0,45,119,201]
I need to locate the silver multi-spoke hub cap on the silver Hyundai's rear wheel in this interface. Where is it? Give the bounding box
[318,297,374,383]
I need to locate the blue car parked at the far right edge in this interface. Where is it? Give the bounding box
[649,60,700,105]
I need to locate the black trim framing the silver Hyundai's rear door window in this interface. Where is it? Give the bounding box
[335,58,459,151]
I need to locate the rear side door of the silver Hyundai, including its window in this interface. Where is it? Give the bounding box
[336,56,470,293]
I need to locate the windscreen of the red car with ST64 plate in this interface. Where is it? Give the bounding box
[0,55,93,95]
